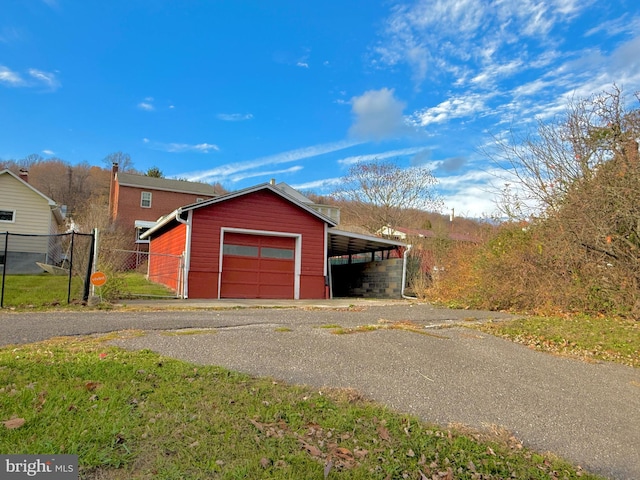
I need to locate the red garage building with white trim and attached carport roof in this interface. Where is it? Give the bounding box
[143,183,403,299]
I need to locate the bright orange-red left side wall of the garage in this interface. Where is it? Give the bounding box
[149,224,187,293]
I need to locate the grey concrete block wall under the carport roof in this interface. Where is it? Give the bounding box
[331,258,402,298]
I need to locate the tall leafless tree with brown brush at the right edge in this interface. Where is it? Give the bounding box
[484,86,640,316]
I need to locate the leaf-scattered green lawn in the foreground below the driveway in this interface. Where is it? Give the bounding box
[0,333,599,480]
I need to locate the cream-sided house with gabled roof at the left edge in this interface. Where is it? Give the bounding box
[0,170,64,273]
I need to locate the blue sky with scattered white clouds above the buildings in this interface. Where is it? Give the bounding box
[0,0,640,217]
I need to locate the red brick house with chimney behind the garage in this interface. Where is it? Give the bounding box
[109,163,217,251]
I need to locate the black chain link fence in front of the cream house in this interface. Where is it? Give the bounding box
[0,232,95,308]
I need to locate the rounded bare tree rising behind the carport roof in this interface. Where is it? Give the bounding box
[333,162,441,233]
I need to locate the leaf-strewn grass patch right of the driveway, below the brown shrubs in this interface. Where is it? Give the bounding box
[474,315,640,367]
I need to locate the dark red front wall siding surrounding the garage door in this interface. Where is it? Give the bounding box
[189,190,325,298]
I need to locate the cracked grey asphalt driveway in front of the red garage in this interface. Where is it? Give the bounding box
[0,303,640,479]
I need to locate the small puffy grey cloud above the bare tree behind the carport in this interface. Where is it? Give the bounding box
[349,88,408,140]
